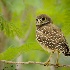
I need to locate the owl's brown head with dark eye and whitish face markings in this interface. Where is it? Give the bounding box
[36,14,52,26]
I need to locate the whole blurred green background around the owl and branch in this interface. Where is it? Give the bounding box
[0,0,70,70]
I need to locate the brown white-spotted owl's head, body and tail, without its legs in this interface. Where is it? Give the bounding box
[36,14,70,65]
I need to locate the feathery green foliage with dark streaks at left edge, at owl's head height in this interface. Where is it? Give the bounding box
[0,16,22,37]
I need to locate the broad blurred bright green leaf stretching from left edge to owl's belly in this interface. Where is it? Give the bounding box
[0,42,44,60]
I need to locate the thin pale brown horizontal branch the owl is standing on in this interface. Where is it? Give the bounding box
[1,60,70,67]
